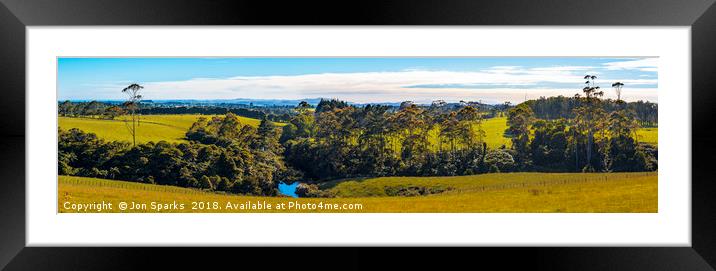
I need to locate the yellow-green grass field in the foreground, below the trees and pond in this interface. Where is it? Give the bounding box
[58,172,658,213]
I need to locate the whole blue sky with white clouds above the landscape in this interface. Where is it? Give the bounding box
[57,57,658,104]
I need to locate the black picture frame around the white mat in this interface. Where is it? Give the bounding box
[0,0,716,270]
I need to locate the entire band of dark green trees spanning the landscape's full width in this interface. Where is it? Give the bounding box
[59,84,658,195]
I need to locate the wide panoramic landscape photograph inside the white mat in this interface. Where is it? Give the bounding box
[56,56,659,213]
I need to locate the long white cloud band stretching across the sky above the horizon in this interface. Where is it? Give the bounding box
[70,61,657,103]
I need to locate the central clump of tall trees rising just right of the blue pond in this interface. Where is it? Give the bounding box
[280,100,504,180]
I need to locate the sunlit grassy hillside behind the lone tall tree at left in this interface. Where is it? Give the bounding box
[58,115,270,143]
